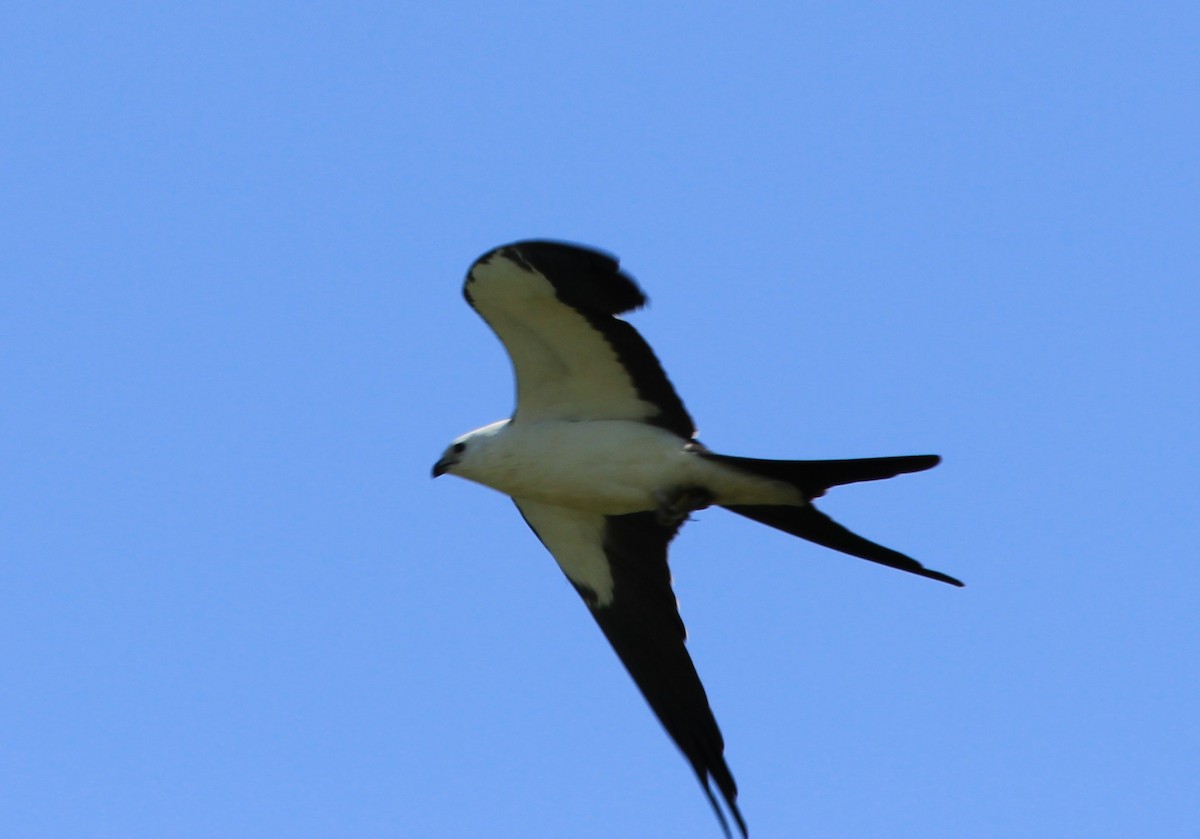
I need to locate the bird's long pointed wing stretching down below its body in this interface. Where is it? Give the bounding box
[516,501,746,835]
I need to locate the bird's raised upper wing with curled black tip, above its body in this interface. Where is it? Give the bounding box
[463,241,695,439]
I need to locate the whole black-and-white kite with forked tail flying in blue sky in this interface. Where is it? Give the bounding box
[433,241,962,837]
